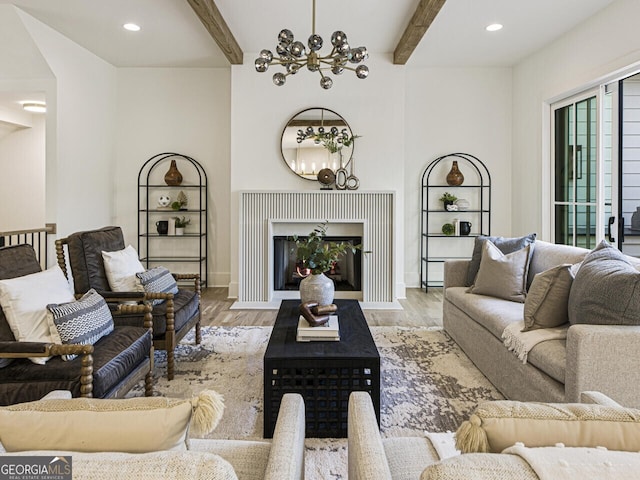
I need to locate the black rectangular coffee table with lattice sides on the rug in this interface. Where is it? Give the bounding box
[264,300,380,438]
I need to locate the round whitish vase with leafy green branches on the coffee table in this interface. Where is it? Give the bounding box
[290,221,369,305]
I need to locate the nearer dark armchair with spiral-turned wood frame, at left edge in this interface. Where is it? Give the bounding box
[0,245,153,405]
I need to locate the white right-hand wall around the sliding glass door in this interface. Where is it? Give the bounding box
[512,0,640,240]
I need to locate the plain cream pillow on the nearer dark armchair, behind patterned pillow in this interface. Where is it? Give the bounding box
[0,265,74,365]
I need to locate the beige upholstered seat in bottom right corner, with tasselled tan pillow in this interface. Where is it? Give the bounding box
[348,392,640,480]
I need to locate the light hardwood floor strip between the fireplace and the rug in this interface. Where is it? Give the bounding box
[202,287,442,327]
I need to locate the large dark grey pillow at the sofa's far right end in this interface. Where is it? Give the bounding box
[569,241,640,325]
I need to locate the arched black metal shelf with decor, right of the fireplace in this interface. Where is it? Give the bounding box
[420,153,491,291]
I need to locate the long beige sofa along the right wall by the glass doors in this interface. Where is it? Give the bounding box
[443,241,640,407]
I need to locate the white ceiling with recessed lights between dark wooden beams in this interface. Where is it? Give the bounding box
[0,0,614,67]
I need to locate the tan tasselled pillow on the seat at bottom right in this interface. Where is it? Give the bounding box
[456,400,640,453]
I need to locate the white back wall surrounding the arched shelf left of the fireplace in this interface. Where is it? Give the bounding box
[114,68,230,286]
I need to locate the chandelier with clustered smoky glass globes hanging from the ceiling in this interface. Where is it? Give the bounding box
[255,0,369,90]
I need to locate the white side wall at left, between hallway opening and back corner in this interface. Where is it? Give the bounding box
[19,11,116,236]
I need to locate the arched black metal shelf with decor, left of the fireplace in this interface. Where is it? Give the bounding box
[138,153,208,287]
